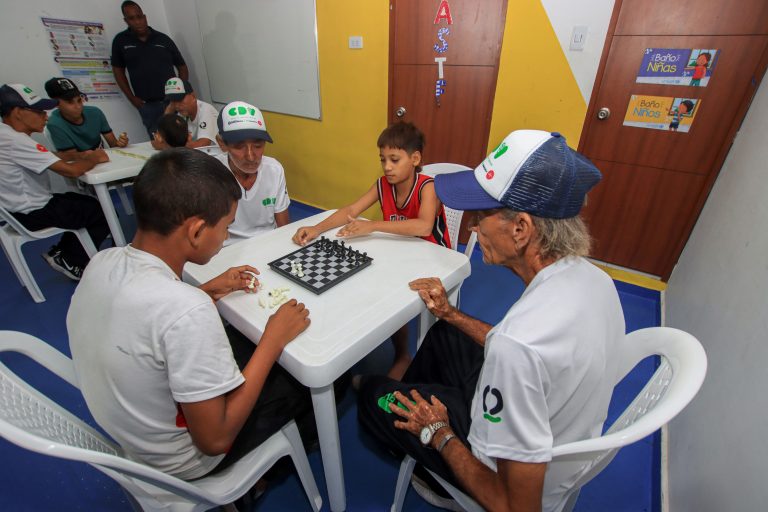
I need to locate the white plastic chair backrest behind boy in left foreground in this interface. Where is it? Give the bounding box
[0,331,225,507]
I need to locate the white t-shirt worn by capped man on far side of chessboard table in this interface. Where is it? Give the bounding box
[216,153,291,245]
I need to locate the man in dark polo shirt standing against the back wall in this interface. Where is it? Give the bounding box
[112,0,189,138]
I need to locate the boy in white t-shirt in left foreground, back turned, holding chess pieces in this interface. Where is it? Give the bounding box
[67,148,314,480]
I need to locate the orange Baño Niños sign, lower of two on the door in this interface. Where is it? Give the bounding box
[624,94,701,132]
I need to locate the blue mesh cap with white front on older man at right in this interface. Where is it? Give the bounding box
[435,130,602,219]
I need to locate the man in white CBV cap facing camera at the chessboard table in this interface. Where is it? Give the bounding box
[216,101,291,245]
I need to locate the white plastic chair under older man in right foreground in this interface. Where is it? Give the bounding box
[391,327,707,512]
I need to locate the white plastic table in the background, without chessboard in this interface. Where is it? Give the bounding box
[80,142,157,247]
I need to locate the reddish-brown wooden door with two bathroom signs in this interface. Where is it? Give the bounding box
[579,0,768,280]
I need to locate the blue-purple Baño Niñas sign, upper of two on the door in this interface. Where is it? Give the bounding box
[636,48,718,87]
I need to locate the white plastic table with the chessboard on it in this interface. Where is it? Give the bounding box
[184,211,470,512]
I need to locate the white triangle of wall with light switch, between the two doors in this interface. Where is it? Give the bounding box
[540,0,614,104]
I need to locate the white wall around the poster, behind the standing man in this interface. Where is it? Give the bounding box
[0,0,174,142]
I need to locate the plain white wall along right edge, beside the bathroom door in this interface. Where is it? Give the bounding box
[666,80,768,512]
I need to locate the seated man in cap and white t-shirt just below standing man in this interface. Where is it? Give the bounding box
[152,77,219,149]
